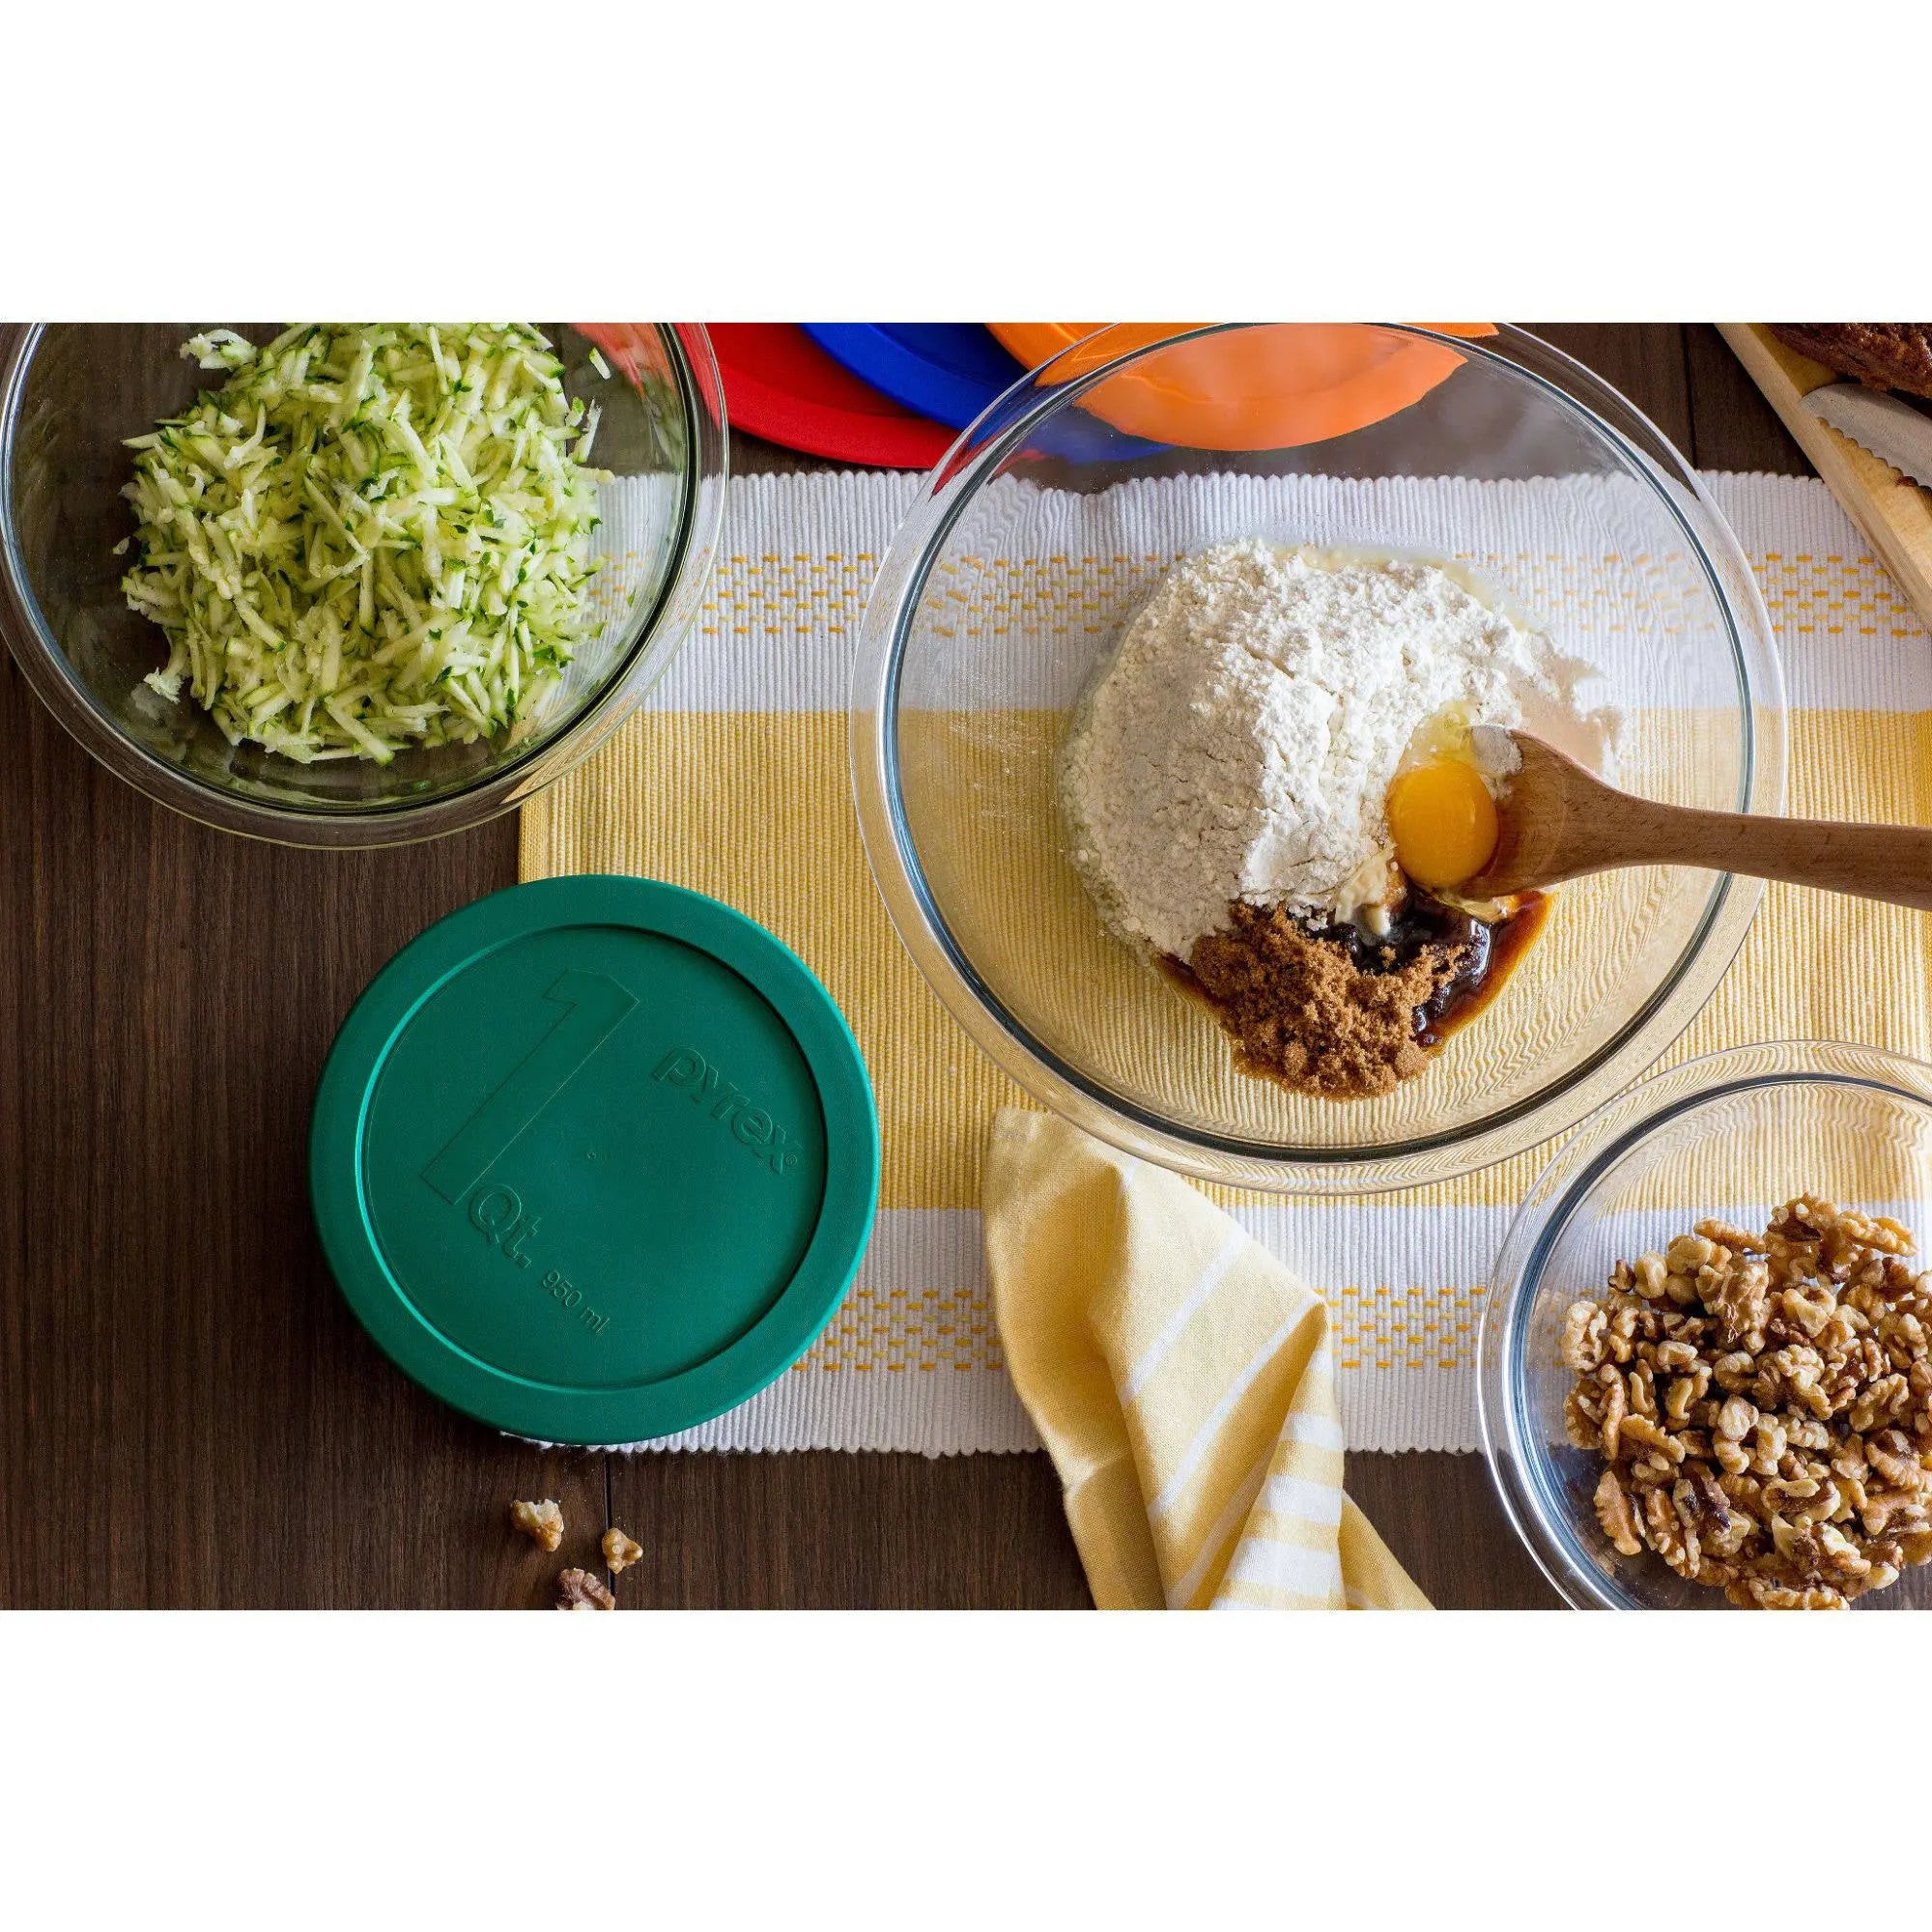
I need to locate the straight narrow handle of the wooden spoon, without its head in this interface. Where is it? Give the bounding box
[1592,804,1932,912]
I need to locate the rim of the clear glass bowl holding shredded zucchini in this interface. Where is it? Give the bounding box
[0,323,730,848]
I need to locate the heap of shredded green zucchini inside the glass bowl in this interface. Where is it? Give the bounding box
[122,323,607,763]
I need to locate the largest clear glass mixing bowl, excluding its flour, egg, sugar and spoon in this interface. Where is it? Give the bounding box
[852,323,1785,1192]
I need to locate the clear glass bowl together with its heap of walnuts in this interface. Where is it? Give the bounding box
[1478,1041,1932,1609]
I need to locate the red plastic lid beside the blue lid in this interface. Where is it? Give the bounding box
[705,323,952,469]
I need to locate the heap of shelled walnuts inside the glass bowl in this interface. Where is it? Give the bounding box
[1559,1194,1932,1609]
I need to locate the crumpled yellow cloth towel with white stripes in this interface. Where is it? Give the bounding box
[985,1107,1430,1609]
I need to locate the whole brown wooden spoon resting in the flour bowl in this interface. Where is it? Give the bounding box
[1459,724,1932,910]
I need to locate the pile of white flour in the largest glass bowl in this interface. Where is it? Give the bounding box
[1061,539,1609,960]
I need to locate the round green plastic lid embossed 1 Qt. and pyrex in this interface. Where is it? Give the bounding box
[309,877,879,1443]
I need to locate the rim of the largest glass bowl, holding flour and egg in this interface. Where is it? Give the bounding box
[850,323,1785,1194]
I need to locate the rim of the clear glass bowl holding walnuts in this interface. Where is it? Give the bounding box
[1476,1039,1932,1609]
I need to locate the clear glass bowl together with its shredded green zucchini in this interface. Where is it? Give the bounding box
[0,323,724,846]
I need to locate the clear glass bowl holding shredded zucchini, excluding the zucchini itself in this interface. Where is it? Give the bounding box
[0,323,726,846]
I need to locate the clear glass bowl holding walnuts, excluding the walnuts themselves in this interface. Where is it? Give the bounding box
[1476,1041,1932,1609]
